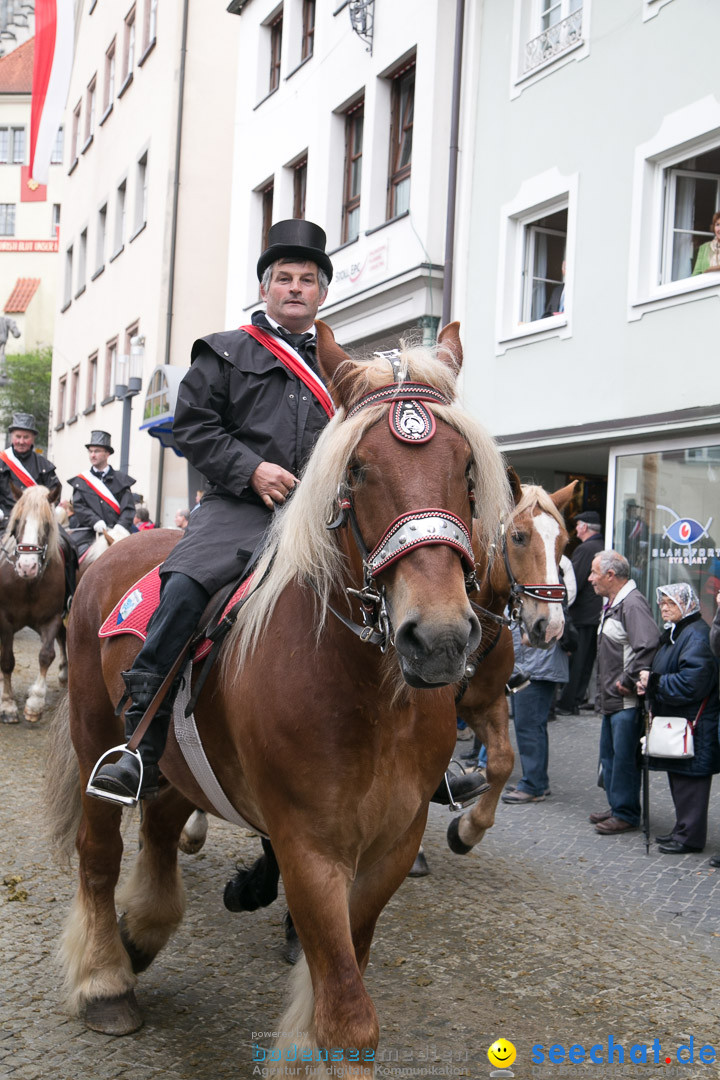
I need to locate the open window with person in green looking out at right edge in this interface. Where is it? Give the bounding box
[660,146,720,284]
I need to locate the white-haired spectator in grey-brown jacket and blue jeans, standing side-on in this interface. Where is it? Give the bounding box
[589,551,660,836]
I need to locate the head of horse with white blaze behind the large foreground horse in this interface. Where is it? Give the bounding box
[504,481,575,649]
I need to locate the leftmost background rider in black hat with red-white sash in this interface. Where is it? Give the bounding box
[0,413,78,604]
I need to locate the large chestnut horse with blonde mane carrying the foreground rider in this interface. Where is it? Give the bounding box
[49,323,510,1078]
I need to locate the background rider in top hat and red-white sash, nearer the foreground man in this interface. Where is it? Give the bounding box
[68,430,135,555]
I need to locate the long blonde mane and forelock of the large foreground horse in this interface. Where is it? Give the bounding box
[223,342,510,674]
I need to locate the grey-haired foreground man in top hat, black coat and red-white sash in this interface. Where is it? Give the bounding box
[87,219,484,801]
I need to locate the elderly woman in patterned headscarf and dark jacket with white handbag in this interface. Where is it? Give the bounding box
[637,582,720,855]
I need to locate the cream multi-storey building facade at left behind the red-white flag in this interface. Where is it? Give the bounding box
[50,0,239,525]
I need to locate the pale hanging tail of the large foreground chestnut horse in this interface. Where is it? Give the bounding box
[45,693,82,866]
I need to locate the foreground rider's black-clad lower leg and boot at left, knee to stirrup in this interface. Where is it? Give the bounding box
[87,572,209,801]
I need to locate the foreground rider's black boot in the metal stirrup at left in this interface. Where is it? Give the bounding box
[90,671,176,799]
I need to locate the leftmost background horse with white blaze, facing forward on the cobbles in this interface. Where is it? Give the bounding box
[0,484,68,724]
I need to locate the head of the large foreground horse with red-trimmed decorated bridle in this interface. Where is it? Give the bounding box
[308,323,507,687]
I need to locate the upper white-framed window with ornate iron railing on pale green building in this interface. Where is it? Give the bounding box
[513,0,590,95]
